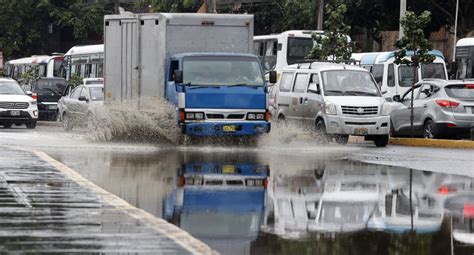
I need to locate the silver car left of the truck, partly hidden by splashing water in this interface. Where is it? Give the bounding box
[58,85,104,131]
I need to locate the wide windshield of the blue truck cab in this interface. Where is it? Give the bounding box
[183,56,264,86]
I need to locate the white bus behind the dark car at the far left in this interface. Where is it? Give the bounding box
[5,53,64,80]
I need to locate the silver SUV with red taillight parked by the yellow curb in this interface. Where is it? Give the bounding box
[390,79,474,138]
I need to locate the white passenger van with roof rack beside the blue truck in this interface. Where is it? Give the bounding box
[275,62,390,147]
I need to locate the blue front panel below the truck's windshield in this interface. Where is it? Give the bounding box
[186,86,267,109]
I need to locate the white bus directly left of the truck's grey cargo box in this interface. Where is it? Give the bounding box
[64,44,104,80]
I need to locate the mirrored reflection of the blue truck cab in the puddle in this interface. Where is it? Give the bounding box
[163,162,270,254]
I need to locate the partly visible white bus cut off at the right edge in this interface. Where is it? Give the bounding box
[455,37,474,80]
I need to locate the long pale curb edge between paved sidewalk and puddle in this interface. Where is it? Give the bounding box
[32,150,218,254]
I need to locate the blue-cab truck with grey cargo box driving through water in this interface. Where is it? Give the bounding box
[104,13,276,136]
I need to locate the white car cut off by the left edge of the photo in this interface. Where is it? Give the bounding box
[0,78,38,129]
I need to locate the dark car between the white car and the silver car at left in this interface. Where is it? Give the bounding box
[26,77,66,120]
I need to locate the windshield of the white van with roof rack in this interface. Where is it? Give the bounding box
[321,70,381,97]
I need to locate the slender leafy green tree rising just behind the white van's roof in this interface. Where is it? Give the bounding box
[308,0,352,60]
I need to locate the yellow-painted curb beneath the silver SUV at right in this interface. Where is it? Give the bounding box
[390,138,474,149]
